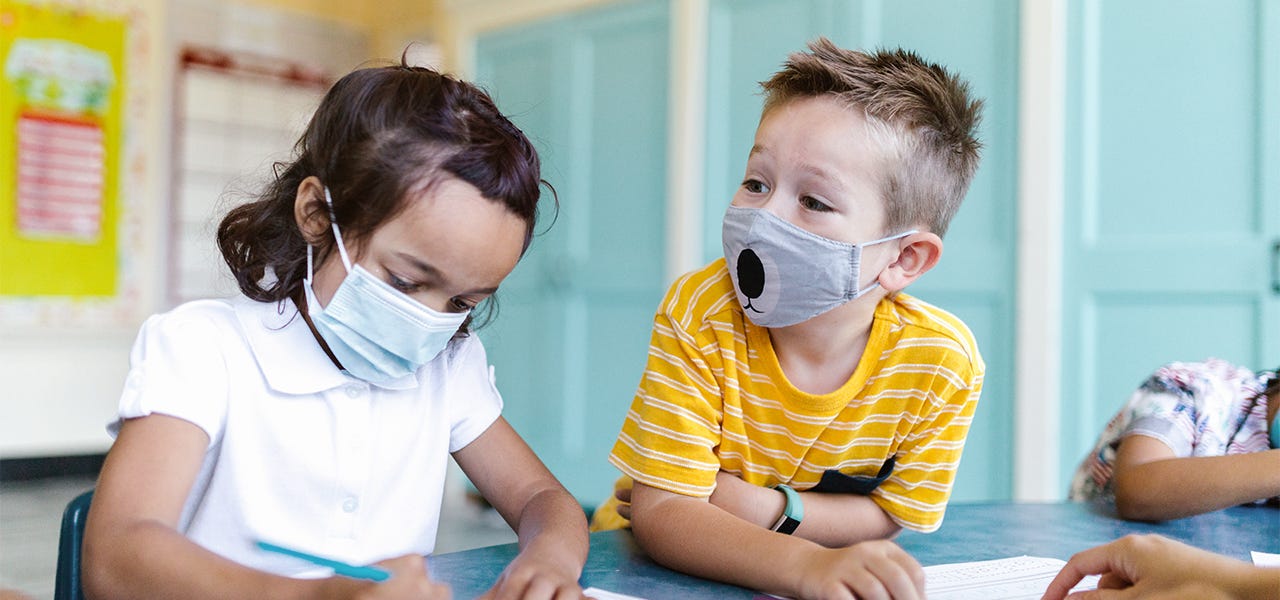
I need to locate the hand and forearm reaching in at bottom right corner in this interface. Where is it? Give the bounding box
[1043,535,1280,600]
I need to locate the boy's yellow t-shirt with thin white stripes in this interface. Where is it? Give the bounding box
[595,258,986,531]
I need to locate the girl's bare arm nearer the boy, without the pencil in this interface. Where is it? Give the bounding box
[453,417,588,599]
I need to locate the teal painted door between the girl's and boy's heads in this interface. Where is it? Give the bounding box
[476,1,668,505]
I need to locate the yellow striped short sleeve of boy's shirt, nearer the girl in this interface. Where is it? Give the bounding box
[609,304,721,498]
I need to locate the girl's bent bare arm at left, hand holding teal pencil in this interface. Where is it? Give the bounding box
[83,414,448,599]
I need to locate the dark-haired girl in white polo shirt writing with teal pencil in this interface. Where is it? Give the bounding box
[84,64,588,599]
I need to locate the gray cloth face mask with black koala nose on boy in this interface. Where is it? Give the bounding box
[721,206,916,328]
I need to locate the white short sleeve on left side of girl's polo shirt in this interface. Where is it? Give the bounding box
[108,312,228,446]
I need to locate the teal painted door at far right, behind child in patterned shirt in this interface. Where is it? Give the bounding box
[1060,0,1280,494]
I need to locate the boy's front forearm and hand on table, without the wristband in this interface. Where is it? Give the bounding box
[631,482,924,599]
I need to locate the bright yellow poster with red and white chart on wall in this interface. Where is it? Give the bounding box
[0,0,127,297]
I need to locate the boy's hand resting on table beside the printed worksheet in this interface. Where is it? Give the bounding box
[794,540,924,600]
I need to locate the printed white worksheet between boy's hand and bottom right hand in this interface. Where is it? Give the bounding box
[924,557,1098,600]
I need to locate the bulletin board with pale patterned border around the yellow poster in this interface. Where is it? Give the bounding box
[0,0,152,336]
